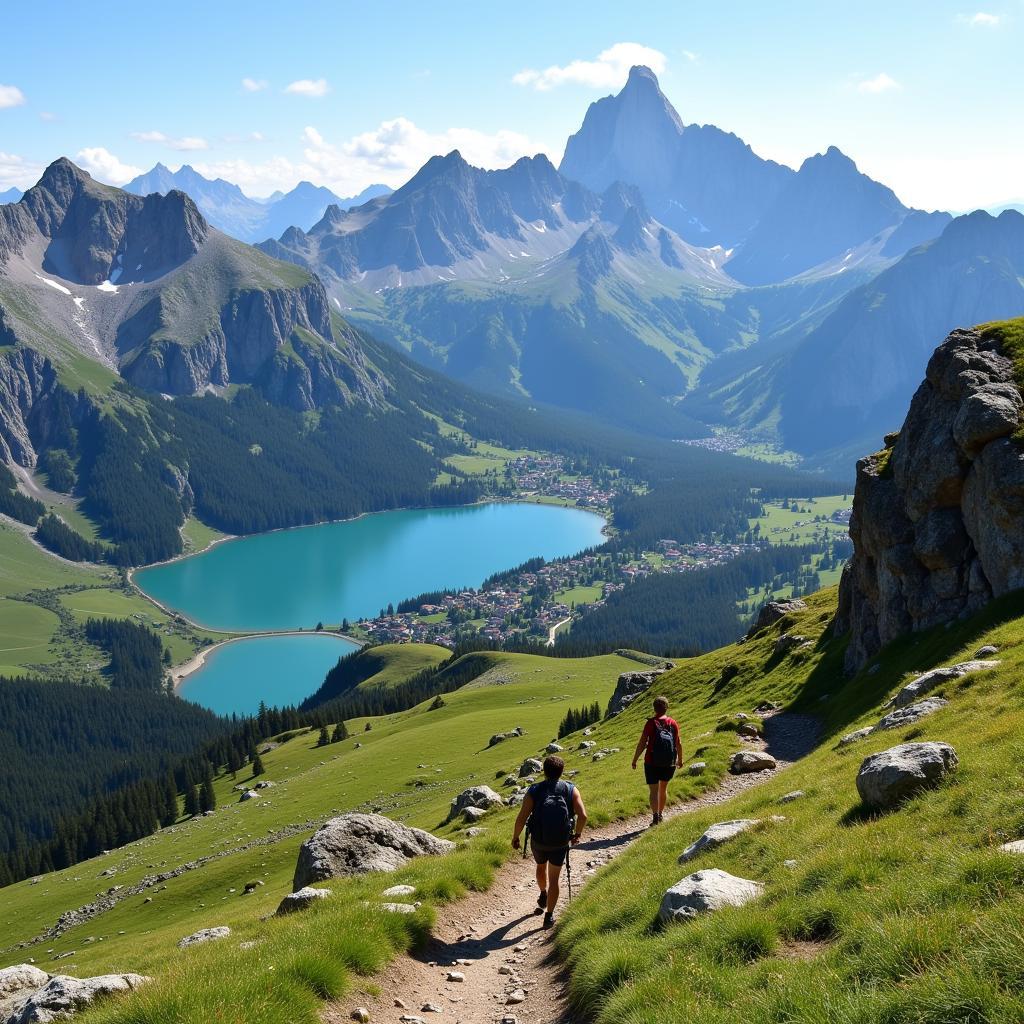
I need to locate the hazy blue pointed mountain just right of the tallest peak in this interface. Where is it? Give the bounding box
[727,146,952,285]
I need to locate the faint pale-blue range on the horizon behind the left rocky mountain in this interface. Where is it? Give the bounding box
[125,164,390,242]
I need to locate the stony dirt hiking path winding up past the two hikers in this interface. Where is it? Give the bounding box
[339,714,818,1024]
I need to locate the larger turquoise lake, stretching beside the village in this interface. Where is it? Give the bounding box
[134,503,604,632]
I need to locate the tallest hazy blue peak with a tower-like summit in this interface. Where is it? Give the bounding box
[559,67,794,248]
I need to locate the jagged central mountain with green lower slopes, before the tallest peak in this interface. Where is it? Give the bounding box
[252,152,741,436]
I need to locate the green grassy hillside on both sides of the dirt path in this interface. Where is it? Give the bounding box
[8,590,1024,1024]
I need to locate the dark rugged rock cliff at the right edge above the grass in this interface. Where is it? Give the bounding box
[837,321,1024,671]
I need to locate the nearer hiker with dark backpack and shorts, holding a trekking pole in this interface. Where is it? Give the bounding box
[512,755,587,928]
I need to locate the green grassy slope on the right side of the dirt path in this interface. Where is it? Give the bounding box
[558,594,1024,1024]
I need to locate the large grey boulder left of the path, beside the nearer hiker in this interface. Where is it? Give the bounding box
[292,814,455,890]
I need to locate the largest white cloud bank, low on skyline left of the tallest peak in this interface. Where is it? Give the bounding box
[195,118,552,196]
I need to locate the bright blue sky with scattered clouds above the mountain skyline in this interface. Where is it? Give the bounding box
[0,0,1024,210]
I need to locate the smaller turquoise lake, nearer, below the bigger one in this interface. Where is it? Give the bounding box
[172,634,358,715]
